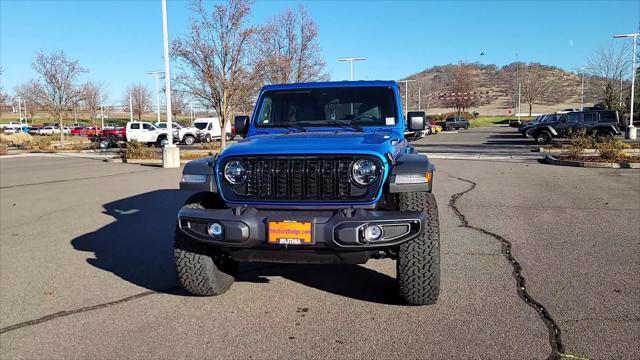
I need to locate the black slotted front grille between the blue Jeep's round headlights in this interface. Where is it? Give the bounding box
[219,155,384,203]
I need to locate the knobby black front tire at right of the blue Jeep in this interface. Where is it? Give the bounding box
[396,192,440,305]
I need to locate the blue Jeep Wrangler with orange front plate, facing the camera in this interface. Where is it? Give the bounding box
[174,81,440,305]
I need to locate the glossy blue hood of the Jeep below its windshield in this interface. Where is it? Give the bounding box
[221,131,405,158]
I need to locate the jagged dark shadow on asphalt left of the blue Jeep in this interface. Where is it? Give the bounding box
[71,189,189,291]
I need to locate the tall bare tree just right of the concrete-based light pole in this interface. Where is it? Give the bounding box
[172,0,258,148]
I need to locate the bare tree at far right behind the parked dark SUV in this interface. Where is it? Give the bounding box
[587,44,631,109]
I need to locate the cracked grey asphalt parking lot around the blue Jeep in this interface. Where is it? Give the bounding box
[0,128,640,359]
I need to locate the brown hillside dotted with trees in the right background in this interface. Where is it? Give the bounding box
[400,63,597,115]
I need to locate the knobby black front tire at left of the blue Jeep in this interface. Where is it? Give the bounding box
[173,203,238,296]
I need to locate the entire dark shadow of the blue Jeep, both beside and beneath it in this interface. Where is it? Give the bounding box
[71,189,400,304]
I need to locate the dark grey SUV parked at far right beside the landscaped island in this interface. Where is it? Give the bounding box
[527,110,620,145]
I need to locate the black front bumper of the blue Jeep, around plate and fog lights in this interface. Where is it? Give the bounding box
[178,207,426,263]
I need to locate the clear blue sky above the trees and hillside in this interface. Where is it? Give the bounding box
[0,0,640,101]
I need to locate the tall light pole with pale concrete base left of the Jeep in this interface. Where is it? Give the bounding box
[158,0,180,168]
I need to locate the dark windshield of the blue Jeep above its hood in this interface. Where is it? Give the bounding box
[256,87,397,127]
